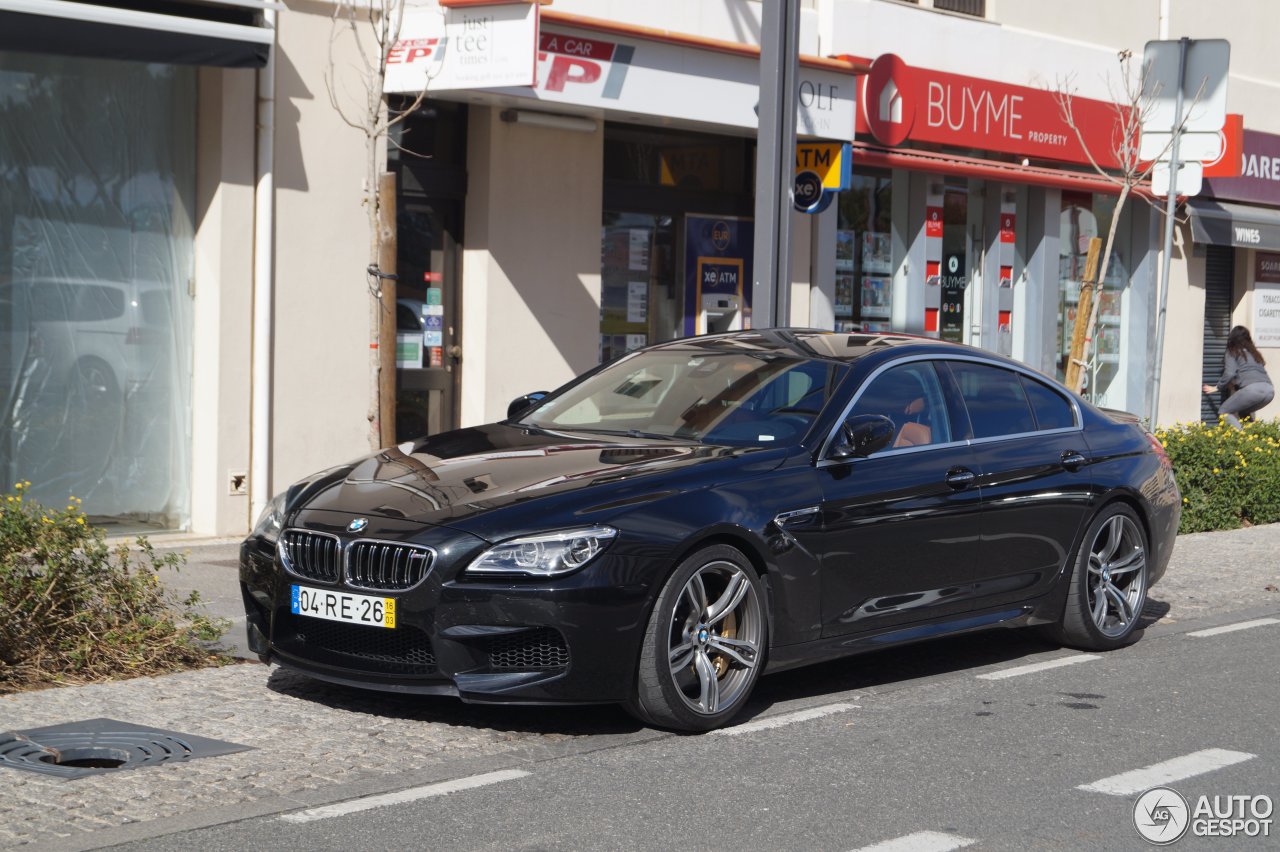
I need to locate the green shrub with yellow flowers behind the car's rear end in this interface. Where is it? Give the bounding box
[1156,421,1280,532]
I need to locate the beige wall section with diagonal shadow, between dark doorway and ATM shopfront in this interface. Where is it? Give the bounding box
[461,106,604,426]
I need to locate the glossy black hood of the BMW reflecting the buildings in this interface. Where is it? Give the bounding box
[293,423,778,528]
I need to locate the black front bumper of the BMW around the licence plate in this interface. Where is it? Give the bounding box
[241,516,655,704]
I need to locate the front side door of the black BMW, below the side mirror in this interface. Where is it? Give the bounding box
[818,359,980,636]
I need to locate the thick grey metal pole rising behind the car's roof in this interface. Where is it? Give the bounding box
[751,0,800,329]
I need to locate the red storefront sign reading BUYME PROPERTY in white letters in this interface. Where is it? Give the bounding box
[858,54,1119,168]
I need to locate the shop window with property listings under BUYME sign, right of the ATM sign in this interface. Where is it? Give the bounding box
[835,171,893,331]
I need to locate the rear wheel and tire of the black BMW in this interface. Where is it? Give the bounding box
[1050,503,1148,651]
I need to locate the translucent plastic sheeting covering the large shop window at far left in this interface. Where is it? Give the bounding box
[0,52,196,528]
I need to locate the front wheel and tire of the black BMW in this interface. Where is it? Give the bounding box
[627,545,769,732]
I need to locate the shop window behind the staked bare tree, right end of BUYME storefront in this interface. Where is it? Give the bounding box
[1057,192,1129,407]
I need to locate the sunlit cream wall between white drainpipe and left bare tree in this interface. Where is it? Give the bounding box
[266,4,370,493]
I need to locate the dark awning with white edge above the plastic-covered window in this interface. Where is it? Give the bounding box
[0,0,276,68]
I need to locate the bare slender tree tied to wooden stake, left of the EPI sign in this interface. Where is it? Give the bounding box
[325,0,426,449]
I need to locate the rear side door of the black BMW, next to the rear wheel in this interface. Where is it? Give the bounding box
[948,361,1092,606]
